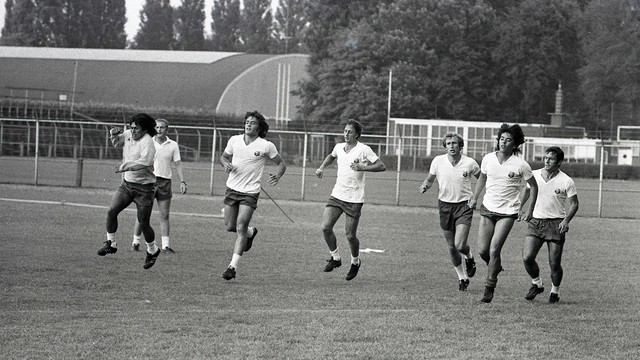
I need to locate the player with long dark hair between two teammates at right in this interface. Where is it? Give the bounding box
[469,124,538,303]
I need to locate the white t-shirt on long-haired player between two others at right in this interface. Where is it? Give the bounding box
[480,152,533,215]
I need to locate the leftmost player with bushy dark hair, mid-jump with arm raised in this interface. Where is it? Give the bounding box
[98,113,160,269]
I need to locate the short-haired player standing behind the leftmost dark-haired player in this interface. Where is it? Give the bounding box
[132,119,187,253]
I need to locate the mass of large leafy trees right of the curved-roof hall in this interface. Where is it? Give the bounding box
[300,0,640,132]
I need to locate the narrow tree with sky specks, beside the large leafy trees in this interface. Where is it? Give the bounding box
[275,0,307,54]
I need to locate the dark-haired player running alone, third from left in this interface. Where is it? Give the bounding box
[220,111,287,280]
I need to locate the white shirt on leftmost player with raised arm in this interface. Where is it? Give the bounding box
[118,130,156,184]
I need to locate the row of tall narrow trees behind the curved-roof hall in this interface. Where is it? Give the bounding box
[0,0,306,53]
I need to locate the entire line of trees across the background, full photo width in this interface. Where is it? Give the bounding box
[0,0,640,132]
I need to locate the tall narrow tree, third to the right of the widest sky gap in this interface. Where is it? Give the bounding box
[211,0,242,52]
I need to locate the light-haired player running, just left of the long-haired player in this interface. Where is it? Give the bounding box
[420,132,480,291]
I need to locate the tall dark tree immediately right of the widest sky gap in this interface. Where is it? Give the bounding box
[134,0,174,50]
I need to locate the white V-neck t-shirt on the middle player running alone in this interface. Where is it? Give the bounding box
[331,142,379,203]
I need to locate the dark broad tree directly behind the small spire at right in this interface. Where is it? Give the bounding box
[493,0,581,123]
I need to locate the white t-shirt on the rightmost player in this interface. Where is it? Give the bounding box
[527,169,578,219]
